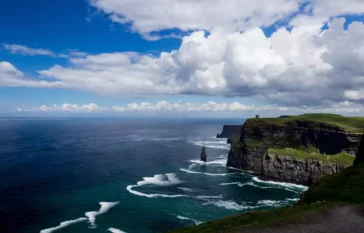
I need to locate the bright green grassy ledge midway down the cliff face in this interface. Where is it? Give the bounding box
[268,148,355,167]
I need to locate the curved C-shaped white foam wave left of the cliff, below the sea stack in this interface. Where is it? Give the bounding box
[126,173,186,198]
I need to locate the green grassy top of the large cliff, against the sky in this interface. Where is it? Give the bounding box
[247,113,364,133]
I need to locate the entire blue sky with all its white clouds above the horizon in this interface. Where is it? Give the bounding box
[0,0,364,118]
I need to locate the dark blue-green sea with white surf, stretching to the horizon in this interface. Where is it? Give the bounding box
[0,118,307,233]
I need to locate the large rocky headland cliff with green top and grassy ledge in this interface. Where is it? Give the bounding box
[227,114,364,185]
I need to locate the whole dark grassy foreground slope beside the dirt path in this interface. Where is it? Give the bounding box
[168,163,364,233]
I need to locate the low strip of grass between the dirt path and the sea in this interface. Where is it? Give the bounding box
[168,202,344,233]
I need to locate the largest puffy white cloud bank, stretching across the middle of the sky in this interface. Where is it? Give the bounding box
[22,16,364,105]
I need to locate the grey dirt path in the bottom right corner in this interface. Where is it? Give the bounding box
[239,206,364,233]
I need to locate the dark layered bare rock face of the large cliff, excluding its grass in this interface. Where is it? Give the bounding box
[227,119,364,185]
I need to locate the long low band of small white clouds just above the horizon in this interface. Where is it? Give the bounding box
[17,101,364,115]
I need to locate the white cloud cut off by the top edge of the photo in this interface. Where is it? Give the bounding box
[89,0,304,35]
